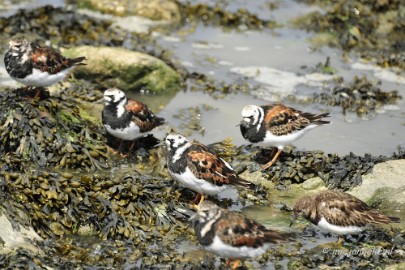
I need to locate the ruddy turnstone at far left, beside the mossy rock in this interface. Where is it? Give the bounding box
[4,36,85,87]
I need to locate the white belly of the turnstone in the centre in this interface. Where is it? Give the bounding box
[169,168,227,195]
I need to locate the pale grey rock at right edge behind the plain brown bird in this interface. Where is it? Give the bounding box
[349,159,405,201]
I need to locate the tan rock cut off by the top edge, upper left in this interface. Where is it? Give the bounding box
[77,0,181,22]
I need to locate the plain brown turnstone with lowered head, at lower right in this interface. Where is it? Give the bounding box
[291,190,400,242]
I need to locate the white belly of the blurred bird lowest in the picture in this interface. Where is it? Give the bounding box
[205,236,269,259]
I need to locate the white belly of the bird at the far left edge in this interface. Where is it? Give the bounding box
[15,67,73,87]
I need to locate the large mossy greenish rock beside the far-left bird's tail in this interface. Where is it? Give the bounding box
[64,46,180,94]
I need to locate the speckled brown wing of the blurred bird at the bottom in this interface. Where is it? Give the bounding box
[215,211,288,248]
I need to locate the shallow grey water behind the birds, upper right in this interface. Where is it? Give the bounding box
[148,19,405,155]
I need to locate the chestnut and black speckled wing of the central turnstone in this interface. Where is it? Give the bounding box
[187,142,253,187]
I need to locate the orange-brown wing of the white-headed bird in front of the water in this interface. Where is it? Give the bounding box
[264,104,311,136]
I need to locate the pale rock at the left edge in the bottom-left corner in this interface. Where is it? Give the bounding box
[0,213,41,253]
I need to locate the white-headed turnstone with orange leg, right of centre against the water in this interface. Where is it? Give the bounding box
[240,104,330,170]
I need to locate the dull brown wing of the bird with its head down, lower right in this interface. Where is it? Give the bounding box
[315,190,393,227]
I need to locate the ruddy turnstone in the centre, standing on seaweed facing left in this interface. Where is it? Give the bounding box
[165,132,254,206]
